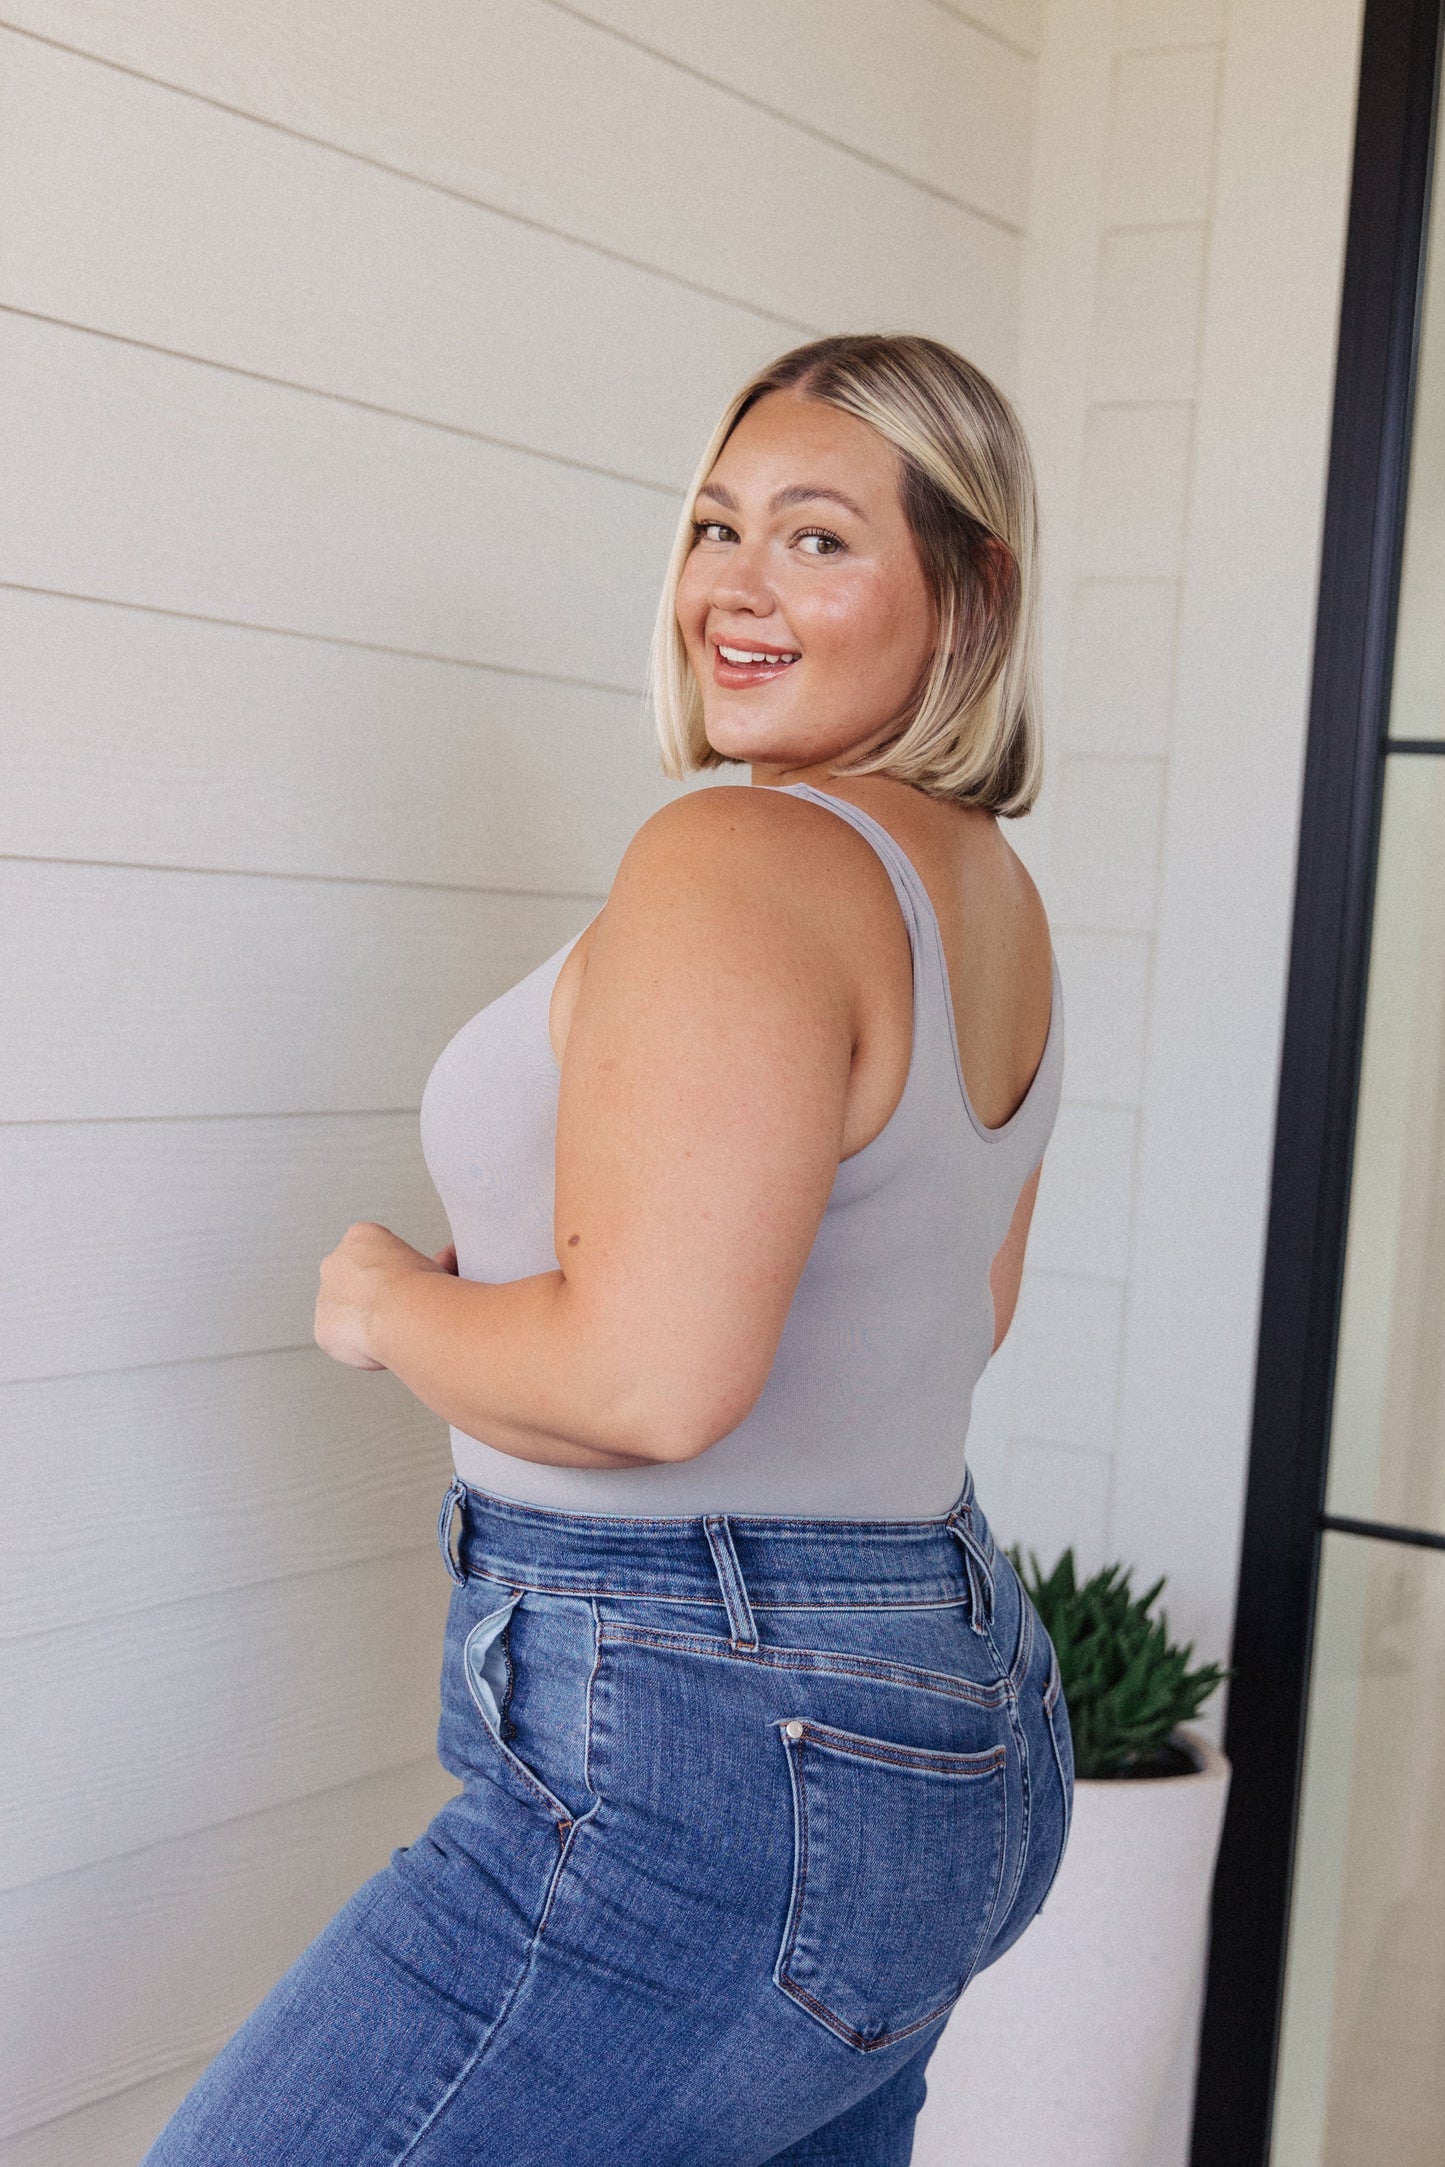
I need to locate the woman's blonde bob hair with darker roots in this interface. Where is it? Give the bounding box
[650,336,1042,819]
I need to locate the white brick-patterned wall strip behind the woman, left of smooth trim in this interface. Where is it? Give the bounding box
[961,0,1226,1594]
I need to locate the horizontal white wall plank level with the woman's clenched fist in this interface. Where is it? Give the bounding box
[0,1114,446,1380]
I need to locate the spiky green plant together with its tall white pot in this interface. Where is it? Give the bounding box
[914,1549,1228,2167]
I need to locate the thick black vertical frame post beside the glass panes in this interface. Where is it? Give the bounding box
[1192,0,1445,2167]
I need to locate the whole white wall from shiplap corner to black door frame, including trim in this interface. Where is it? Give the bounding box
[919,0,1361,2167]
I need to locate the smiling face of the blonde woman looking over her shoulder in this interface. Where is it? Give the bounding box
[678,390,938,782]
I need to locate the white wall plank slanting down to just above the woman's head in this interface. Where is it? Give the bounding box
[6,0,1020,368]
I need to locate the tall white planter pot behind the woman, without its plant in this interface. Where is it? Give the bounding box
[914,1729,1228,2167]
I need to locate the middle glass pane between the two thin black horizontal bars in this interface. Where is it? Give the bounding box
[1328,752,1445,1534]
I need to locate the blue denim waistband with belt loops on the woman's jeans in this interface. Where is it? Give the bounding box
[438,1469,997,1645]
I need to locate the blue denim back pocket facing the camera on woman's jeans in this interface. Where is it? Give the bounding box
[773,1721,1007,2052]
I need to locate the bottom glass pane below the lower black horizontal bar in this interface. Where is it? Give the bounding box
[1270,1534,1445,2167]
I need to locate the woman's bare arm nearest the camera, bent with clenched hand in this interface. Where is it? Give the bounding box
[316,787,858,1467]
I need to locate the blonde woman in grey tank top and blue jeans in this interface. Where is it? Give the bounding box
[149,338,1072,2167]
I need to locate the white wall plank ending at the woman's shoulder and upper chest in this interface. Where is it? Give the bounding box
[0,860,602,1120]
